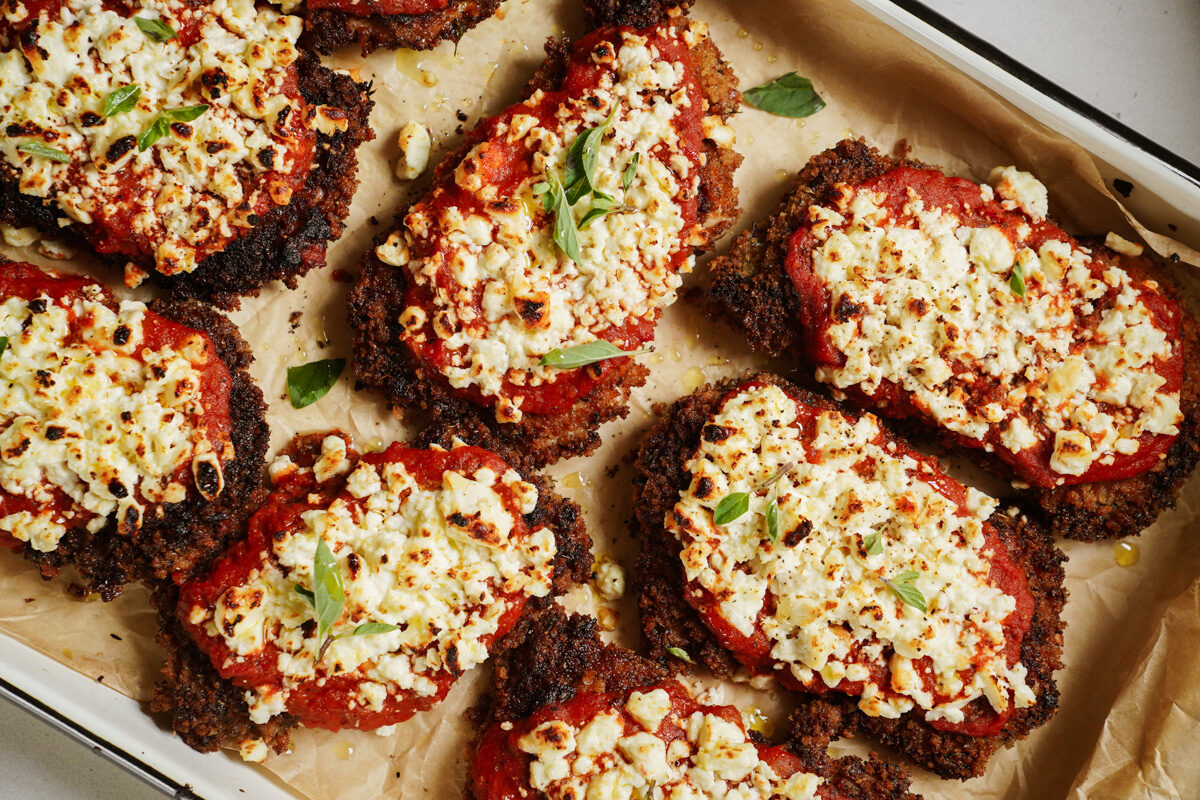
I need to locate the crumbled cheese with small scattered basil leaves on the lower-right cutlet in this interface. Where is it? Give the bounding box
[666,385,1034,722]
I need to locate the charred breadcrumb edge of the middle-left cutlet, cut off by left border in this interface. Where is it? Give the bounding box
[0,268,270,600]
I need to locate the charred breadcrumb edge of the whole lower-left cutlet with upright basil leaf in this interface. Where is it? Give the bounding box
[150,426,592,753]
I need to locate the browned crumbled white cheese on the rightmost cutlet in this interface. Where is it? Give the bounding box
[810,168,1183,482]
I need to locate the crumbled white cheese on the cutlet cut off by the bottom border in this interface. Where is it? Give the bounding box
[517,688,822,800]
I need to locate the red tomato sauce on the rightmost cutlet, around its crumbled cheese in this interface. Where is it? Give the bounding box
[786,167,1183,487]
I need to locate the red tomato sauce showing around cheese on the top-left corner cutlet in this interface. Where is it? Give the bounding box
[0,0,316,273]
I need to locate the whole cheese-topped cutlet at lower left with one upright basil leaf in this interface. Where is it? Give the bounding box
[158,424,589,752]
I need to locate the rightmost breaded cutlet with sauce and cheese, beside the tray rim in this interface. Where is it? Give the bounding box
[712,142,1198,539]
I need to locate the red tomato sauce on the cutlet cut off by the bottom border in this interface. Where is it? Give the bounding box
[468,681,842,800]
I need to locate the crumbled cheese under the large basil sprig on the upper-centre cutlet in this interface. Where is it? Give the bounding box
[376,21,719,422]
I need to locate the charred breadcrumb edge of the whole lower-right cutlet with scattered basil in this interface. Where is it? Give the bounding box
[634,374,1067,778]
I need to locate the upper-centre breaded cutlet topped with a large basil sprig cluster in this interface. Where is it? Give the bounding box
[349,0,739,464]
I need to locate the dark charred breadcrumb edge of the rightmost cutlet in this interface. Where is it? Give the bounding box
[708,139,1200,541]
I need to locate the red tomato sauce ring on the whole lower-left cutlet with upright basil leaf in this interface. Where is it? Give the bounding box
[178,444,529,730]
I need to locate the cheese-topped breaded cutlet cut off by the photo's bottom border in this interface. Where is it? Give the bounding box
[467,608,913,800]
